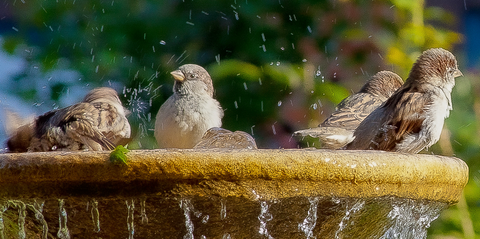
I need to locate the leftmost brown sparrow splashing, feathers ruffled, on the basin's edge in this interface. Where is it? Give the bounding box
[7,87,130,152]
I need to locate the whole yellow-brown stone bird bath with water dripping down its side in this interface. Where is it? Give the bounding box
[0,149,468,238]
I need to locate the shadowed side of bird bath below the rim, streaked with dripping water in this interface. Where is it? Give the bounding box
[0,196,447,239]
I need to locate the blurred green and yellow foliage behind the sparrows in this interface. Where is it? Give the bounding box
[2,0,480,238]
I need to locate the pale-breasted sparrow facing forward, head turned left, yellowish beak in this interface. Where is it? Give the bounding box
[155,64,223,148]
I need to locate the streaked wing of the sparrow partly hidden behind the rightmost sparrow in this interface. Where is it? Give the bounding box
[319,93,383,130]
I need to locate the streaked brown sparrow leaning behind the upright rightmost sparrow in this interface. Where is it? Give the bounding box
[294,71,403,149]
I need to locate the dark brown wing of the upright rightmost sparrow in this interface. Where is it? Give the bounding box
[370,92,431,152]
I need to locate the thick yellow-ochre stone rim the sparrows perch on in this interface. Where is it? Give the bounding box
[0,149,468,204]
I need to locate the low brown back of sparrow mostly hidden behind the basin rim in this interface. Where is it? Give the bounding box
[193,127,257,149]
